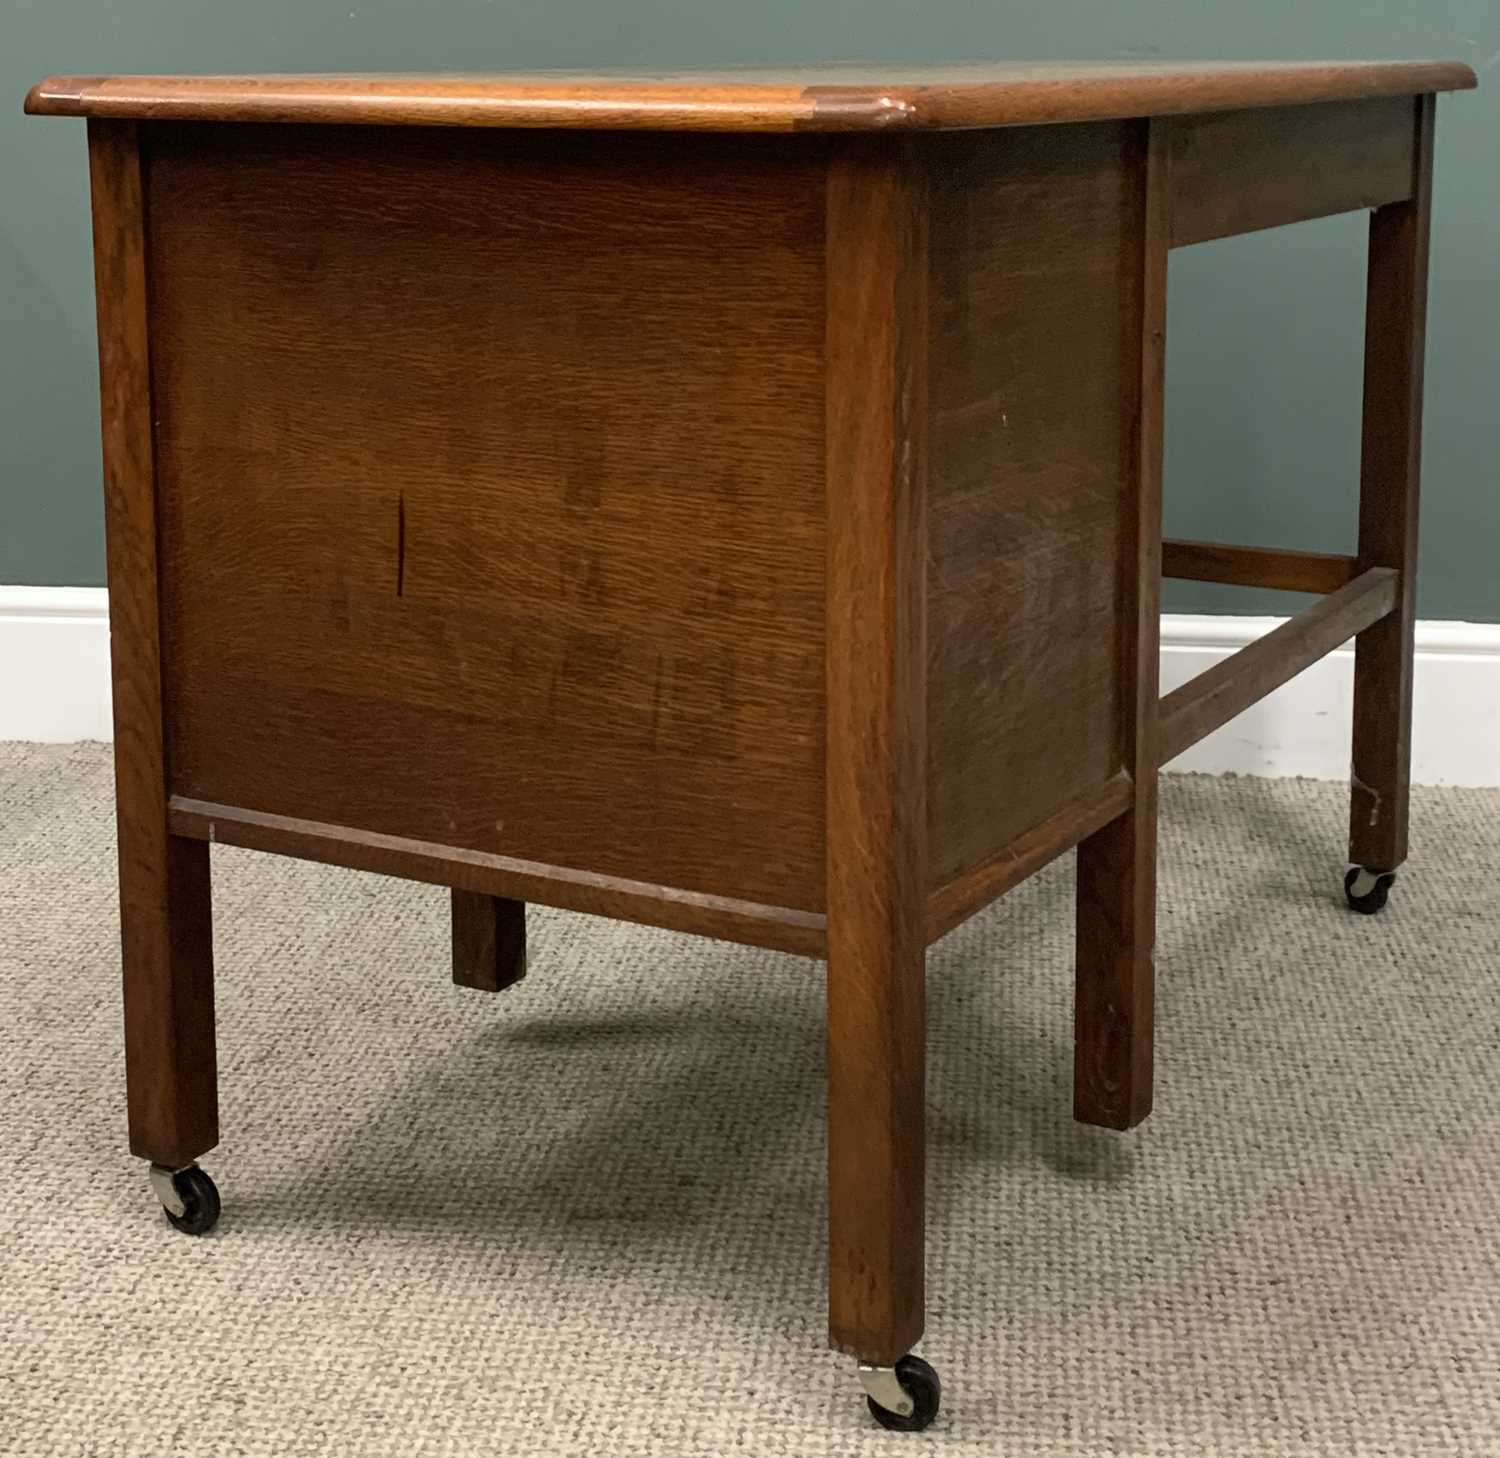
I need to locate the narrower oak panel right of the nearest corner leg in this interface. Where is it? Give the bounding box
[927,123,1140,891]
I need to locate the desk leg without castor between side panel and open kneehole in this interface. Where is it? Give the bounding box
[1073,122,1172,1130]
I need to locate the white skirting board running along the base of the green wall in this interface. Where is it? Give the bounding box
[0,587,1500,785]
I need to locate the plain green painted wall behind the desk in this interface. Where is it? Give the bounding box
[0,0,1500,621]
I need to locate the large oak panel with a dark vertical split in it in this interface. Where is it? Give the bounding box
[149,126,825,911]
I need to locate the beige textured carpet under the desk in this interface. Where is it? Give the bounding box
[0,746,1500,1458]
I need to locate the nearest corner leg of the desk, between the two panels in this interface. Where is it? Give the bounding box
[825,138,929,1364]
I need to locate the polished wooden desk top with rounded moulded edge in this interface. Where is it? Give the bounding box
[26,62,1476,132]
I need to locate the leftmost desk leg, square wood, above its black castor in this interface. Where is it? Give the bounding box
[89,122,219,1167]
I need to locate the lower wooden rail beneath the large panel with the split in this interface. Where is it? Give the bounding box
[170,795,825,957]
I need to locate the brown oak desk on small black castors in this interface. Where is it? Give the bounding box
[27,63,1475,1428]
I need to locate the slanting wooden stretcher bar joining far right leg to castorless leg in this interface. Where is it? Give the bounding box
[1160,567,1400,764]
